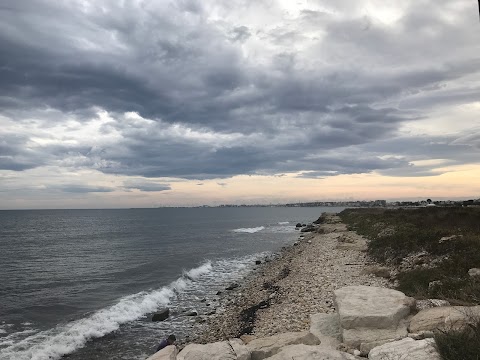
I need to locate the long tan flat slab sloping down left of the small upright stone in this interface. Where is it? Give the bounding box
[247,331,320,360]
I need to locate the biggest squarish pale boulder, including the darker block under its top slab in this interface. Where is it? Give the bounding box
[334,286,415,347]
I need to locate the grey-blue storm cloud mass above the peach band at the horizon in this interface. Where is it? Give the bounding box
[0,0,480,181]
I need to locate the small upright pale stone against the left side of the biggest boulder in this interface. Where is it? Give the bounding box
[310,313,342,349]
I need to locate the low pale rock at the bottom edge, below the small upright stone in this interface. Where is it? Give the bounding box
[267,345,362,360]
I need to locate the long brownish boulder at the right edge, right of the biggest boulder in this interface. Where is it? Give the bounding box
[409,305,480,333]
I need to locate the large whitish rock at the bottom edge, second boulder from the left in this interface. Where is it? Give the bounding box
[177,339,251,360]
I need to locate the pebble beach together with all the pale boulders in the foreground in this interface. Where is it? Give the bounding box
[148,214,480,360]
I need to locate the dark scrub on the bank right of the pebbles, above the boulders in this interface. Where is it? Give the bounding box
[340,208,480,304]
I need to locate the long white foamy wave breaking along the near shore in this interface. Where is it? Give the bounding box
[0,262,212,360]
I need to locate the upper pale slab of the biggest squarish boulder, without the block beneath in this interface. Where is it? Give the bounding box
[334,286,415,329]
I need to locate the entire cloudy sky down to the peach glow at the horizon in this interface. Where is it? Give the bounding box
[0,0,480,209]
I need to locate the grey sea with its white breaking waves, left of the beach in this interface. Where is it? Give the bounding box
[0,207,342,360]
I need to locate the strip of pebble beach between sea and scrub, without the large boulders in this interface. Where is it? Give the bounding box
[189,214,392,344]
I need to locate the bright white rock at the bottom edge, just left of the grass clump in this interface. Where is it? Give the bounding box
[368,338,440,360]
